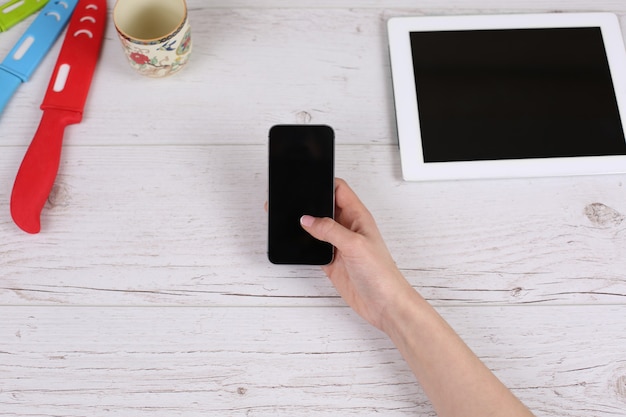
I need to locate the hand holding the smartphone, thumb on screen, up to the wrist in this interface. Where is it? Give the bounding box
[300,178,412,330]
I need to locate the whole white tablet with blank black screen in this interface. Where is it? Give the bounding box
[388,13,626,181]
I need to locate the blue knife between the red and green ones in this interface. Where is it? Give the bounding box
[0,0,78,114]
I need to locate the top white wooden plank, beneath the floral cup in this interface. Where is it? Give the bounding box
[0,0,626,146]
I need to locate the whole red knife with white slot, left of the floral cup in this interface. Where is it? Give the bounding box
[11,0,107,233]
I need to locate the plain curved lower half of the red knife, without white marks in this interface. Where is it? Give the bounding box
[11,109,82,233]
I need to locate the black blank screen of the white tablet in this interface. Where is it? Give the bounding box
[411,27,626,162]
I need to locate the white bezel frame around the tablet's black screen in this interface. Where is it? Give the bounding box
[388,13,626,181]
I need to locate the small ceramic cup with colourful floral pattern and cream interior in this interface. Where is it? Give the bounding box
[113,0,191,78]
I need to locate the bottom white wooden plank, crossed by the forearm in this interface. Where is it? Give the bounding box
[0,306,626,417]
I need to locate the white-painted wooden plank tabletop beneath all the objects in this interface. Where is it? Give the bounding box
[0,0,626,417]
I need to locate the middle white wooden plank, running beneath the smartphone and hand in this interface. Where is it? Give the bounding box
[0,144,626,305]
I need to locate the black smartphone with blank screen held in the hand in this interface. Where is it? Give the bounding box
[267,125,335,265]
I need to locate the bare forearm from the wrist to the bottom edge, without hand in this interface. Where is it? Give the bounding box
[383,291,532,417]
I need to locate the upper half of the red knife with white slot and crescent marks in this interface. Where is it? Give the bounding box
[41,0,107,112]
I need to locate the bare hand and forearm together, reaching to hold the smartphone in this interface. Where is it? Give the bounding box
[300,179,533,417]
